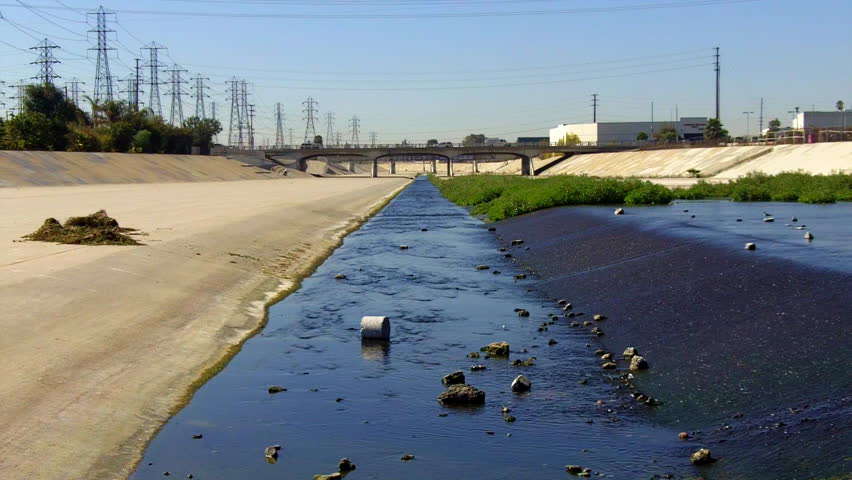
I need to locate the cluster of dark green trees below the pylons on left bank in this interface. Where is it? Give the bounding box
[0,84,222,154]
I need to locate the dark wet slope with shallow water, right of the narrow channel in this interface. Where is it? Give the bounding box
[495,204,852,479]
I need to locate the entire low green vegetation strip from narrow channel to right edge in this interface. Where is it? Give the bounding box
[430,173,852,222]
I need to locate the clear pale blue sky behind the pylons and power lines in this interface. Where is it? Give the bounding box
[0,0,852,144]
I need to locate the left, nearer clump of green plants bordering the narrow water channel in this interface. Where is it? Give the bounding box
[431,175,674,221]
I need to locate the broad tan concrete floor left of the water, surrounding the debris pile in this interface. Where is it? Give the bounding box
[0,178,406,479]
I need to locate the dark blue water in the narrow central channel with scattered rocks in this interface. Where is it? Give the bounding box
[131,178,696,480]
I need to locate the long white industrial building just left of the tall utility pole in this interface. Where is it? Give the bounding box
[550,117,707,145]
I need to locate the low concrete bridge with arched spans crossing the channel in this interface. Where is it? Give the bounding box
[263,144,636,177]
